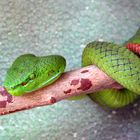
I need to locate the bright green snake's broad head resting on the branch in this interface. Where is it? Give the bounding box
[4,54,66,96]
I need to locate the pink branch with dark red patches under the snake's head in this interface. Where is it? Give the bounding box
[0,65,122,115]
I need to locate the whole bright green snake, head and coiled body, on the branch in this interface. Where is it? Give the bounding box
[4,29,140,108]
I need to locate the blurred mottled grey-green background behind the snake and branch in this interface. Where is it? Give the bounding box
[0,0,140,140]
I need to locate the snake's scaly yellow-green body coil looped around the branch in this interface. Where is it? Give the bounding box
[82,41,140,108]
